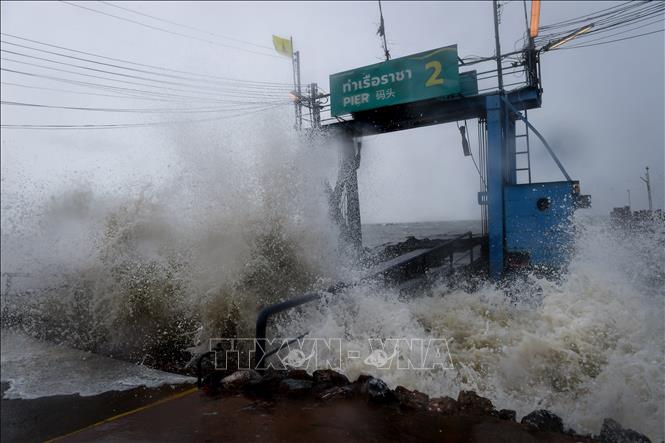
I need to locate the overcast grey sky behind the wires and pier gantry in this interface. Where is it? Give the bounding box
[1,1,665,222]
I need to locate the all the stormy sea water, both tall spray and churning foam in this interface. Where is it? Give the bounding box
[1,115,665,440]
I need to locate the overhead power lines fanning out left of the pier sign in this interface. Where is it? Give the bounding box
[0,1,293,129]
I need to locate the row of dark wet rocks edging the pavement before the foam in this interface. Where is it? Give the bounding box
[209,369,650,443]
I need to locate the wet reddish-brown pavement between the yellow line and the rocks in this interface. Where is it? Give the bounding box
[29,391,586,443]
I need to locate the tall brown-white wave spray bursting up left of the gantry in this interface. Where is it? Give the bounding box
[2,111,347,367]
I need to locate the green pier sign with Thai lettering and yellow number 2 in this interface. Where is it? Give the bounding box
[330,45,464,116]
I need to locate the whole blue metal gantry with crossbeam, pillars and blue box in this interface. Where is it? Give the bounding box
[326,80,590,279]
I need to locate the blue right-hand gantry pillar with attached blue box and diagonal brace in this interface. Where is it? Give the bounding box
[479,91,590,278]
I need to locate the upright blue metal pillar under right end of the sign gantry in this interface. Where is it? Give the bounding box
[486,95,506,279]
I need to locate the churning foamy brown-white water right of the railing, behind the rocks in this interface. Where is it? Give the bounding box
[278,218,665,440]
